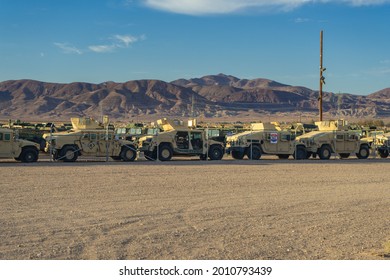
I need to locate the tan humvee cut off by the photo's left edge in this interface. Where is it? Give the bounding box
[0,128,39,162]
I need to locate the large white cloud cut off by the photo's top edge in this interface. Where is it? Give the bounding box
[143,0,390,15]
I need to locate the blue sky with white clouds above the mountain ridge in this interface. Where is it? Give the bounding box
[0,0,390,95]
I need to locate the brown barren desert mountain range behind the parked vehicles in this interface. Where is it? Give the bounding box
[0,74,390,120]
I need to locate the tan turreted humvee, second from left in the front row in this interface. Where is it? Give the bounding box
[44,118,137,162]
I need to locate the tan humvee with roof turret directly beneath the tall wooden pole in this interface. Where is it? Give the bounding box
[297,120,370,159]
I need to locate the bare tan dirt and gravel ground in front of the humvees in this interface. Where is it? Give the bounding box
[0,159,390,260]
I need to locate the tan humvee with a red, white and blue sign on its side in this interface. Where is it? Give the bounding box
[226,123,306,160]
